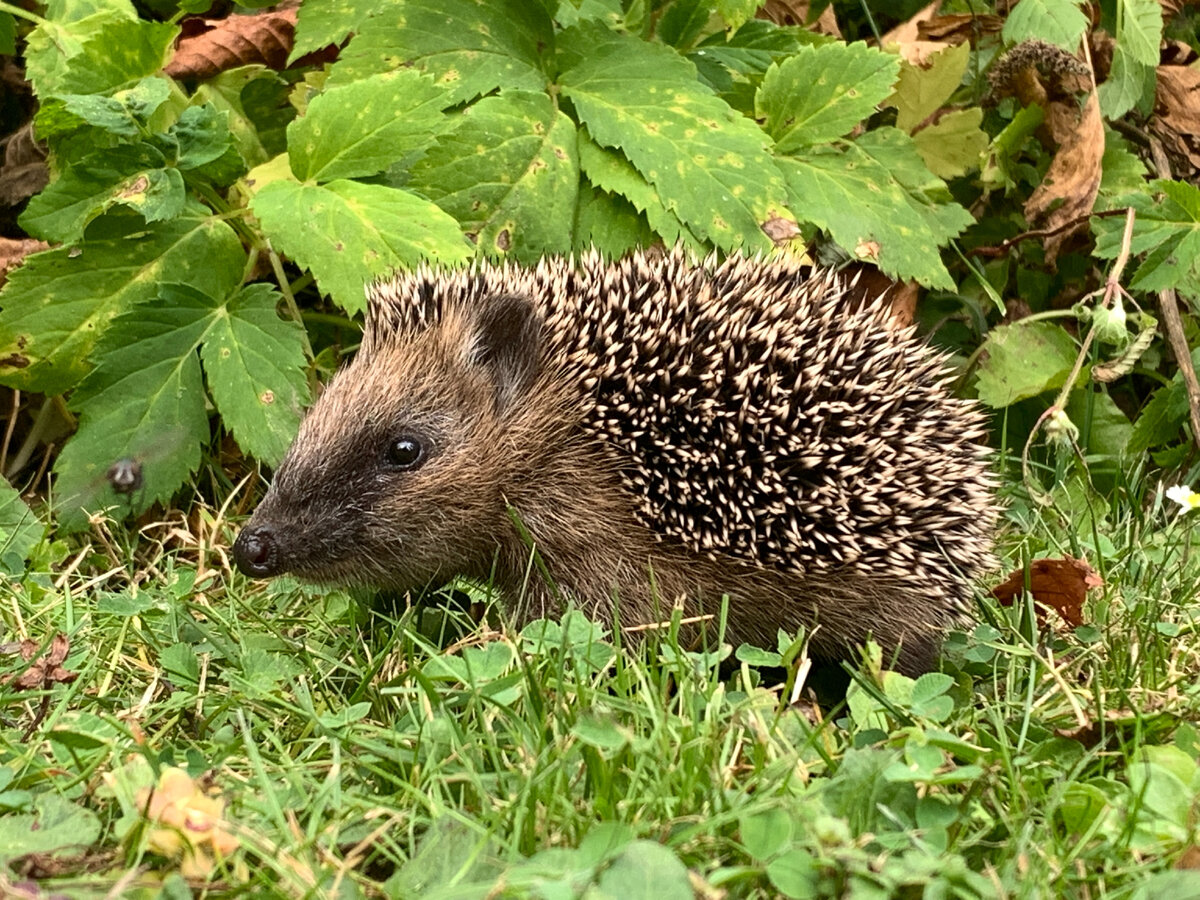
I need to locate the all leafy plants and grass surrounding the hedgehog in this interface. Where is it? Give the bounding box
[0,0,1200,900]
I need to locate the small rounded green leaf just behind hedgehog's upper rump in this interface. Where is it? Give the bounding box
[977,322,1079,409]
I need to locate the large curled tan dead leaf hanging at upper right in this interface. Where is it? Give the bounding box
[1025,91,1104,263]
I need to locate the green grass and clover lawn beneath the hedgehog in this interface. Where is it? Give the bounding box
[0,465,1200,900]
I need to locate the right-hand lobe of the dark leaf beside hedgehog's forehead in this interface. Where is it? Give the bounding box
[200,284,308,466]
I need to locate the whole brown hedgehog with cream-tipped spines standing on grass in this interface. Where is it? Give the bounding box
[234,248,997,673]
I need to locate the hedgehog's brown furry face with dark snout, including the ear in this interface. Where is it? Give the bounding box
[234,296,541,590]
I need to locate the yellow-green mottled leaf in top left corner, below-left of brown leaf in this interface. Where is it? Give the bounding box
[26,13,179,98]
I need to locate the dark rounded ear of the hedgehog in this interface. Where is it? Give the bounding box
[467,294,541,412]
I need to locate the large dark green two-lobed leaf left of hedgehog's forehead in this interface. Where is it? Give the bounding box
[54,284,307,529]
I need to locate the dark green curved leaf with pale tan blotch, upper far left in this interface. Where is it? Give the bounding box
[20,143,187,244]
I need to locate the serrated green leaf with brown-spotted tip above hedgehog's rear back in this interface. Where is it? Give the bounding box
[780,128,974,288]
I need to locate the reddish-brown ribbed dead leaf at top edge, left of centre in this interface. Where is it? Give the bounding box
[163,8,296,78]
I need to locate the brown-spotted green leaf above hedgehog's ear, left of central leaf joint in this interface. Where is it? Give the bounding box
[408,91,580,262]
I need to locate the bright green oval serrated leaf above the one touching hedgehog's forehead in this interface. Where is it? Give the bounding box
[288,68,456,181]
